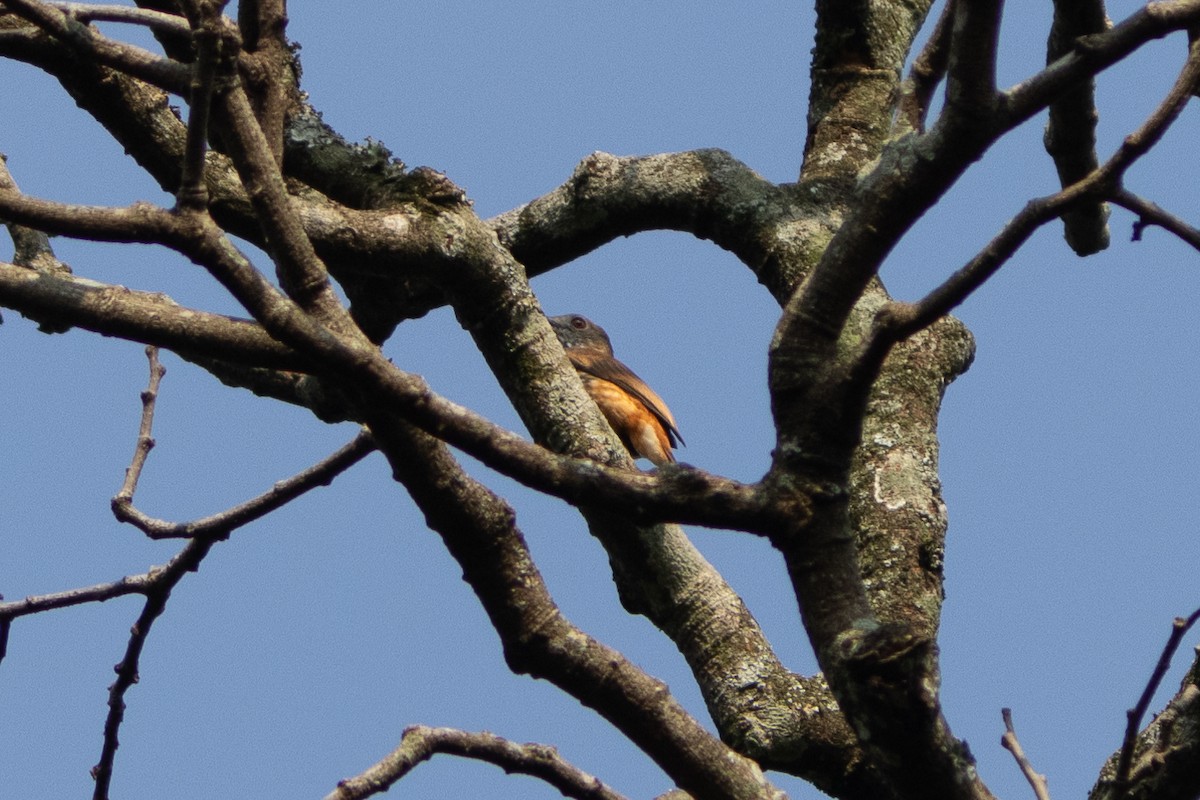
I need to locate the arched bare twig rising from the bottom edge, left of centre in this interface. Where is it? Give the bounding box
[325,726,624,800]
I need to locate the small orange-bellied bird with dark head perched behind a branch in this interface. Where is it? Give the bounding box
[550,314,683,467]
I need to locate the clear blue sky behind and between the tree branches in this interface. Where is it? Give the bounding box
[0,0,1200,800]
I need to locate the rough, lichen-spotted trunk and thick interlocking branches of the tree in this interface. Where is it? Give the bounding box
[0,0,1200,800]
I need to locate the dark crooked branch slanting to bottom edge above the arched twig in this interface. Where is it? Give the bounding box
[368,407,779,800]
